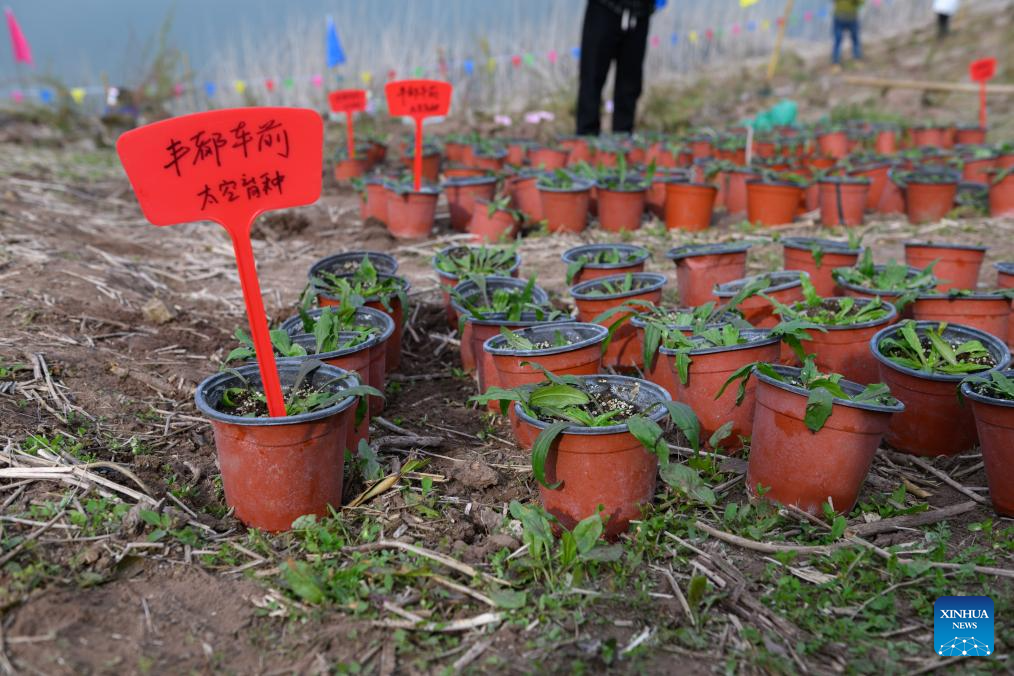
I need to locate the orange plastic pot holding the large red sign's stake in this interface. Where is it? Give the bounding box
[195,360,359,532]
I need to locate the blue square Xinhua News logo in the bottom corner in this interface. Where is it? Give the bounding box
[933,596,996,657]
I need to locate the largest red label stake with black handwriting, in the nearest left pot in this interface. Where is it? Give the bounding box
[117,107,323,418]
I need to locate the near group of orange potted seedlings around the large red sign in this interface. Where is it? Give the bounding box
[191,235,1014,534]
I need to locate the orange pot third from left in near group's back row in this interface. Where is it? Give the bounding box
[665,242,750,307]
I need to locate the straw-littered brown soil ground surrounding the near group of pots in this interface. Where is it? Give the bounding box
[0,129,1014,674]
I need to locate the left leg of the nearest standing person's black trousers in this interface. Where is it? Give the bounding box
[577,0,623,136]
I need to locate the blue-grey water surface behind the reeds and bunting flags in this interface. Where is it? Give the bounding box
[0,0,839,85]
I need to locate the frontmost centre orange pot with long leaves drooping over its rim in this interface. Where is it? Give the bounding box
[514,376,669,539]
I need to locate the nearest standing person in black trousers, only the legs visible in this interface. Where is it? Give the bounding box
[577,0,664,136]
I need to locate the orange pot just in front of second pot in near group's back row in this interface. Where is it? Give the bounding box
[570,273,667,368]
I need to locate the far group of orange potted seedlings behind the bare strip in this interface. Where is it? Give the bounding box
[338,130,1014,242]
